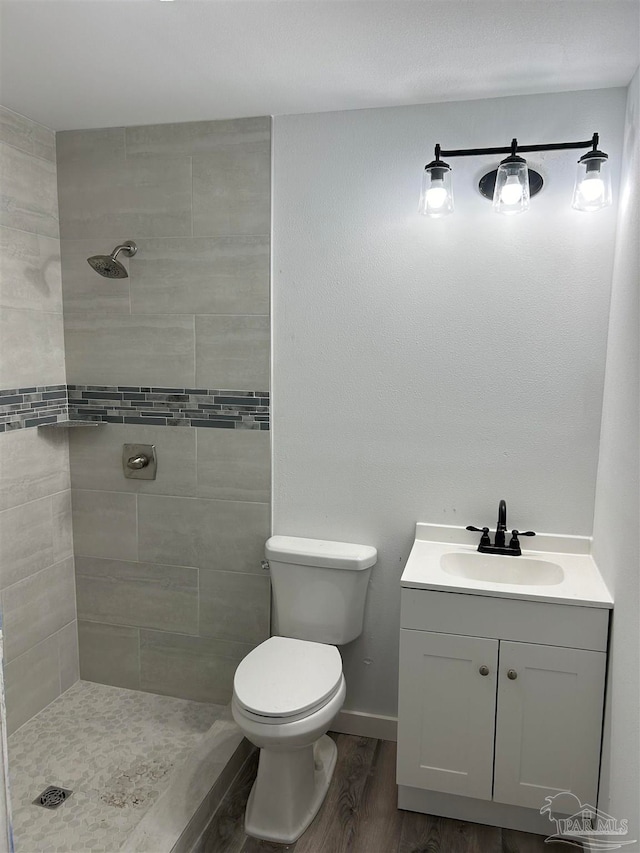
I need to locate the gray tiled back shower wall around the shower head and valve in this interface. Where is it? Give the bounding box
[57,118,271,702]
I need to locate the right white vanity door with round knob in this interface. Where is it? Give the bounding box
[493,641,606,810]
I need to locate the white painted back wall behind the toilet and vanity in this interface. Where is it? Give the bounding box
[272,89,626,714]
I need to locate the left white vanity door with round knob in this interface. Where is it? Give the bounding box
[397,629,498,800]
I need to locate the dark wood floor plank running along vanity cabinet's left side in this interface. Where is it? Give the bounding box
[350,740,403,853]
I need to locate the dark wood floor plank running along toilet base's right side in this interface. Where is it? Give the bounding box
[296,735,377,853]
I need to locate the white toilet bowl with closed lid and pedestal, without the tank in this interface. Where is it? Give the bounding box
[231,637,346,844]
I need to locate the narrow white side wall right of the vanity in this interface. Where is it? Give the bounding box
[593,72,640,850]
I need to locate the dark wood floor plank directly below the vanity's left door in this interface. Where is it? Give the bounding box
[398,812,502,853]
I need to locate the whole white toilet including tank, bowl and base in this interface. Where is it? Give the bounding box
[231,536,377,844]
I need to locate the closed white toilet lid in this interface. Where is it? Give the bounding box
[233,637,342,717]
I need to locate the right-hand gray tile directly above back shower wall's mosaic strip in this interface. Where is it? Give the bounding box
[196,315,270,390]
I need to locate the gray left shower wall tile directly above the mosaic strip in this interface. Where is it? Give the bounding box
[0,308,65,388]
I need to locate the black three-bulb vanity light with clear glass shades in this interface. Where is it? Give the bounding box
[419,133,611,219]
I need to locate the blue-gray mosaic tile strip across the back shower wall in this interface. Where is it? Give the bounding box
[67,385,269,430]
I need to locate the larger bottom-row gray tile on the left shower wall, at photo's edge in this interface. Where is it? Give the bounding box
[4,639,60,734]
